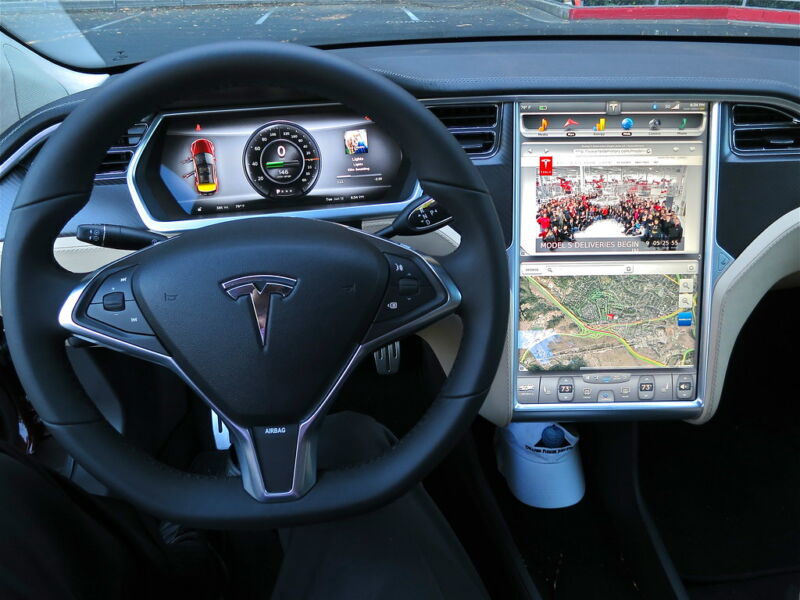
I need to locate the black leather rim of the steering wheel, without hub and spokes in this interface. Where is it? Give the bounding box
[0,42,509,528]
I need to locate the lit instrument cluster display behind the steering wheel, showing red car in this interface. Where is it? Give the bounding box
[158,107,402,216]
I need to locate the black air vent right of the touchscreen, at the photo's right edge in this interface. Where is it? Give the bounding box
[732,104,800,154]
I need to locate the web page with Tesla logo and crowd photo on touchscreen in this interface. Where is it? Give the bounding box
[520,142,702,256]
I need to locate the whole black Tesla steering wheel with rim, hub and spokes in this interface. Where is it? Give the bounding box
[2,42,509,528]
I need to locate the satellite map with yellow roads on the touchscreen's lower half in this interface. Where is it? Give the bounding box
[518,274,697,372]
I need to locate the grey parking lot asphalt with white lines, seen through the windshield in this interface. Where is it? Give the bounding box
[6,0,564,65]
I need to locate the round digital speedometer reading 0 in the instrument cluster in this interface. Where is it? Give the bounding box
[244,121,320,198]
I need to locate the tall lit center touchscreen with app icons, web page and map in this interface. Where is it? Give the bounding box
[516,100,707,405]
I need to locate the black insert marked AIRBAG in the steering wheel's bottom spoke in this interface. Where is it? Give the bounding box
[251,424,299,494]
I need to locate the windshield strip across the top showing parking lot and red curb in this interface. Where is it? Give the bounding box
[0,0,800,69]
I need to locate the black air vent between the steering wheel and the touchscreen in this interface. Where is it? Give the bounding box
[428,104,500,155]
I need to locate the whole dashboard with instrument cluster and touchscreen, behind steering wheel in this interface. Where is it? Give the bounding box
[0,41,800,424]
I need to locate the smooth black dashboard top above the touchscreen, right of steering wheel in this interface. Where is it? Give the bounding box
[332,40,800,99]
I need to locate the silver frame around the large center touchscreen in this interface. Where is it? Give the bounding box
[507,95,720,420]
